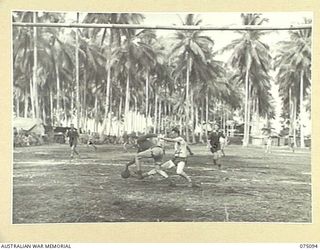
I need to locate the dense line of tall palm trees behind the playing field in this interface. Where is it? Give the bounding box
[12,12,311,145]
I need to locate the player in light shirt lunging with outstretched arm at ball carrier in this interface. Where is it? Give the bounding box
[161,128,197,187]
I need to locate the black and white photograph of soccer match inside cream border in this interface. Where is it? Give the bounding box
[10,9,314,224]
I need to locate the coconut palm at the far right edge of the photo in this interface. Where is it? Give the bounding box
[274,19,311,147]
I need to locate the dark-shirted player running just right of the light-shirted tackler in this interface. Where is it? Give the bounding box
[208,124,225,169]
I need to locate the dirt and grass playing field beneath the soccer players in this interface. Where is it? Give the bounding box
[12,144,312,224]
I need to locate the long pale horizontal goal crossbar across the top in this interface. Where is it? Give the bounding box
[12,22,312,31]
